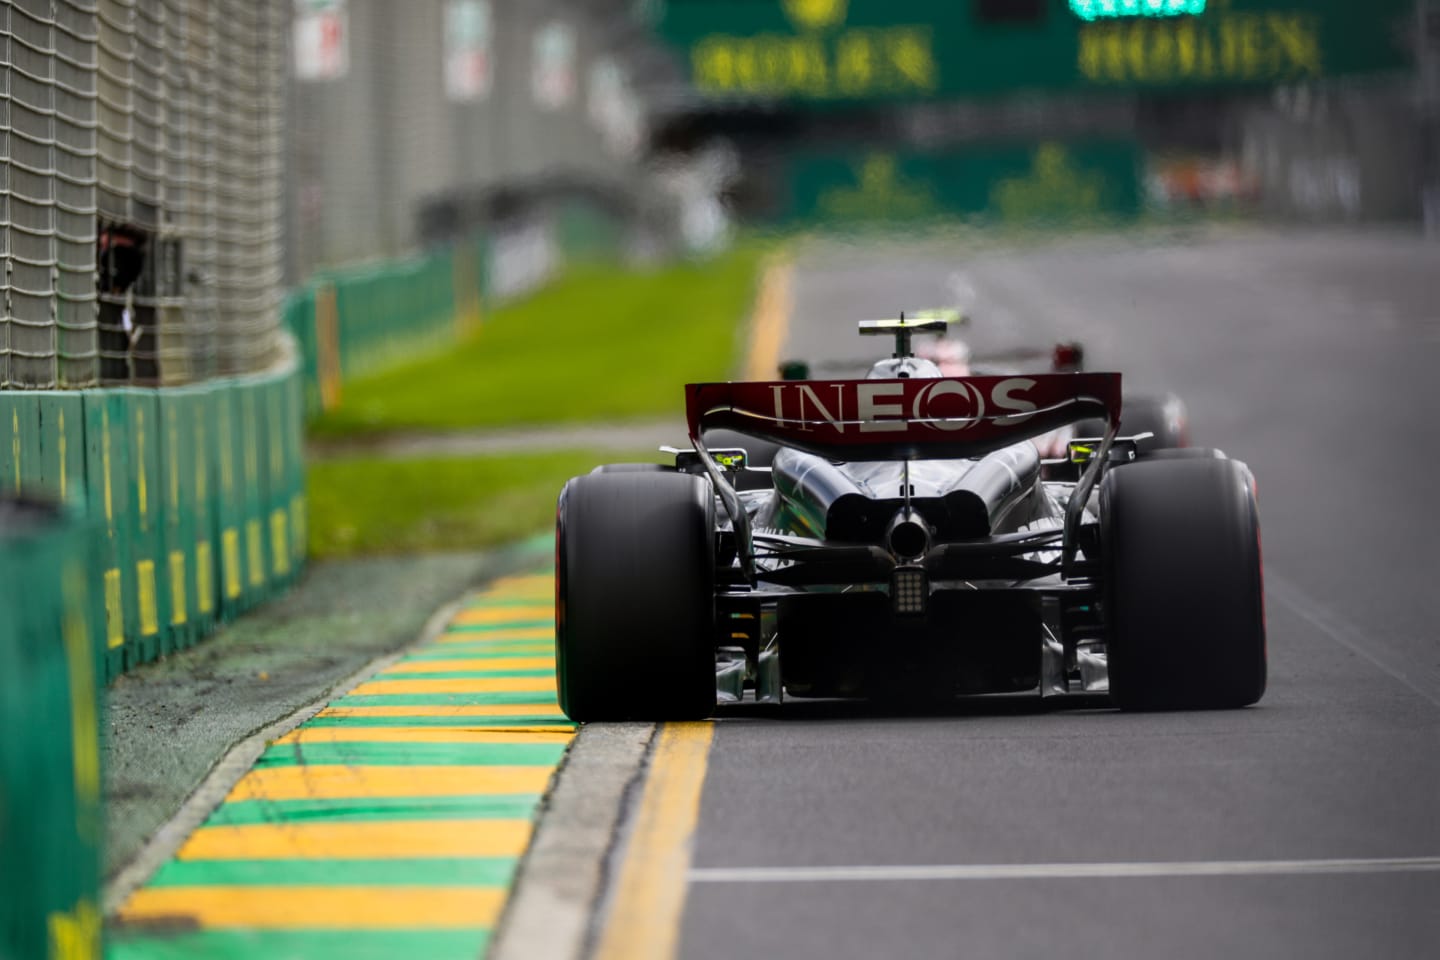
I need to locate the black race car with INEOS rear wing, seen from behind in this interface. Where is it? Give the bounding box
[556,318,1266,721]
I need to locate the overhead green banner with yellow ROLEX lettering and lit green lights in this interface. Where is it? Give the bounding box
[654,0,1414,104]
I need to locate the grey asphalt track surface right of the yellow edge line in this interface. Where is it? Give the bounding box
[680,232,1440,960]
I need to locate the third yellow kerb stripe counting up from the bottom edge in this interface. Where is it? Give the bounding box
[225,764,552,803]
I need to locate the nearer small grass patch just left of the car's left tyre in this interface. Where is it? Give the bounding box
[310,450,655,560]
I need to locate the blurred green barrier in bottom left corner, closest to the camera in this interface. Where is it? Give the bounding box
[0,500,102,960]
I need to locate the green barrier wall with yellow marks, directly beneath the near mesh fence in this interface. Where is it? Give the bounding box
[0,355,305,678]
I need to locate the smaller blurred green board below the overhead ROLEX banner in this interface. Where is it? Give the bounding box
[775,141,1142,227]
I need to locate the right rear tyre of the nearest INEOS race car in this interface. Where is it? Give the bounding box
[1100,458,1266,710]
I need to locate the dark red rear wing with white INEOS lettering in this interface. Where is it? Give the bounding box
[685,373,1120,461]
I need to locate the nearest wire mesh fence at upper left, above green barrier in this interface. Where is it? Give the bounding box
[0,0,289,389]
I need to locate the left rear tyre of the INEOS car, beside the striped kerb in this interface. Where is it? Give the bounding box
[554,471,716,721]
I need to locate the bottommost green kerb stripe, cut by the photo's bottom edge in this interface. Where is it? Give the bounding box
[105,928,490,960]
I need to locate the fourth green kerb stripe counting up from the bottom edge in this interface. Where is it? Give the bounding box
[255,743,566,769]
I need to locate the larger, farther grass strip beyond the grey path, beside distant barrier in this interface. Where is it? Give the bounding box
[311,243,763,439]
